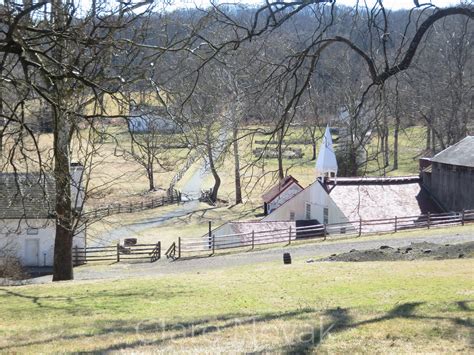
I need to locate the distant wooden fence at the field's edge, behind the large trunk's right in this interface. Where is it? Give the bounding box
[82,190,182,219]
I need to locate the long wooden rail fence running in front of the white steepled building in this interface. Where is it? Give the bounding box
[165,210,474,259]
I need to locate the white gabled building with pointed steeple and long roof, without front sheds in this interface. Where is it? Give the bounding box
[262,127,440,231]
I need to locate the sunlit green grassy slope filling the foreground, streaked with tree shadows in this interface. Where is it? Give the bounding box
[0,260,474,353]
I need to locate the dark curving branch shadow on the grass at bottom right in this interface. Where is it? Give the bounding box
[276,301,474,354]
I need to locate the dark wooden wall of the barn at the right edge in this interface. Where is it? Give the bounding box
[429,162,474,211]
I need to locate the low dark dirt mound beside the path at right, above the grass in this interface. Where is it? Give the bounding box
[321,242,474,261]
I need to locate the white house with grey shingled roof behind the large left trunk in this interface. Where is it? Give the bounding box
[0,164,86,266]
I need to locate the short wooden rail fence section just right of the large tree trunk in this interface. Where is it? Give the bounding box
[74,242,161,265]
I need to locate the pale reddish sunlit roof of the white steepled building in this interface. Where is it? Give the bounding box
[330,176,442,221]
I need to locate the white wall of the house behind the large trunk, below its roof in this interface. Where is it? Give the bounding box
[0,220,86,266]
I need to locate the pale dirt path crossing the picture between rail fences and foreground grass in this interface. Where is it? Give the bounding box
[32,231,474,283]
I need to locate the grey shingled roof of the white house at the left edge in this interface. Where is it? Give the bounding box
[0,173,56,219]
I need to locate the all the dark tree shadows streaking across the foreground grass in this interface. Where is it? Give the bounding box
[0,301,474,354]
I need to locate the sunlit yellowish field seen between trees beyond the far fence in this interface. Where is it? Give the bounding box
[0,122,425,208]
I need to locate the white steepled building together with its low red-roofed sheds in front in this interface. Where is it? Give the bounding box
[206,127,442,245]
